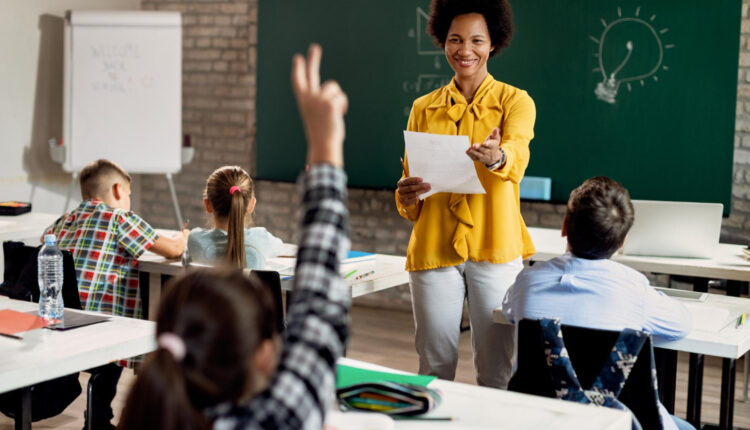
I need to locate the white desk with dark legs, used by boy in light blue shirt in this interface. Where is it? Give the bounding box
[492,294,750,429]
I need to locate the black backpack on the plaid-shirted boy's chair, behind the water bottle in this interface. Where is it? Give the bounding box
[0,242,81,421]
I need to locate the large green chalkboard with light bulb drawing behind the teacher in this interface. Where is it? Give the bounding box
[257,0,741,210]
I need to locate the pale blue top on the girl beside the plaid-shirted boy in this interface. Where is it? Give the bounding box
[188,227,283,270]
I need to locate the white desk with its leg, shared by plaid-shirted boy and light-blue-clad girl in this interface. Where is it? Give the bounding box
[138,252,409,319]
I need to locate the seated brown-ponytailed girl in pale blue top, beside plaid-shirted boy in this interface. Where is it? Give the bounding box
[188,166,283,269]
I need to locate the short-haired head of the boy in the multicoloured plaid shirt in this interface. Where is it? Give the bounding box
[79,159,131,211]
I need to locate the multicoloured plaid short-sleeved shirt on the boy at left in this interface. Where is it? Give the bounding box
[47,199,158,318]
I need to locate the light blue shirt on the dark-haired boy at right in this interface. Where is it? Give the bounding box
[503,253,692,429]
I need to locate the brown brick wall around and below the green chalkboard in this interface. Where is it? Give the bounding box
[141,0,750,306]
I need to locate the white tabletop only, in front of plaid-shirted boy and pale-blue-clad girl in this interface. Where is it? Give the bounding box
[138,252,409,297]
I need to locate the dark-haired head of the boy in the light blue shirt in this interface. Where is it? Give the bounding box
[563,176,635,260]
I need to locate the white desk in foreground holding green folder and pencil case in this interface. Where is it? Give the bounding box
[339,358,631,430]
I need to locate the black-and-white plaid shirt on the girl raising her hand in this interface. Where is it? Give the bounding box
[211,165,349,430]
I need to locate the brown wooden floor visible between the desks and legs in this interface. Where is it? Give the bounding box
[0,306,750,430]
